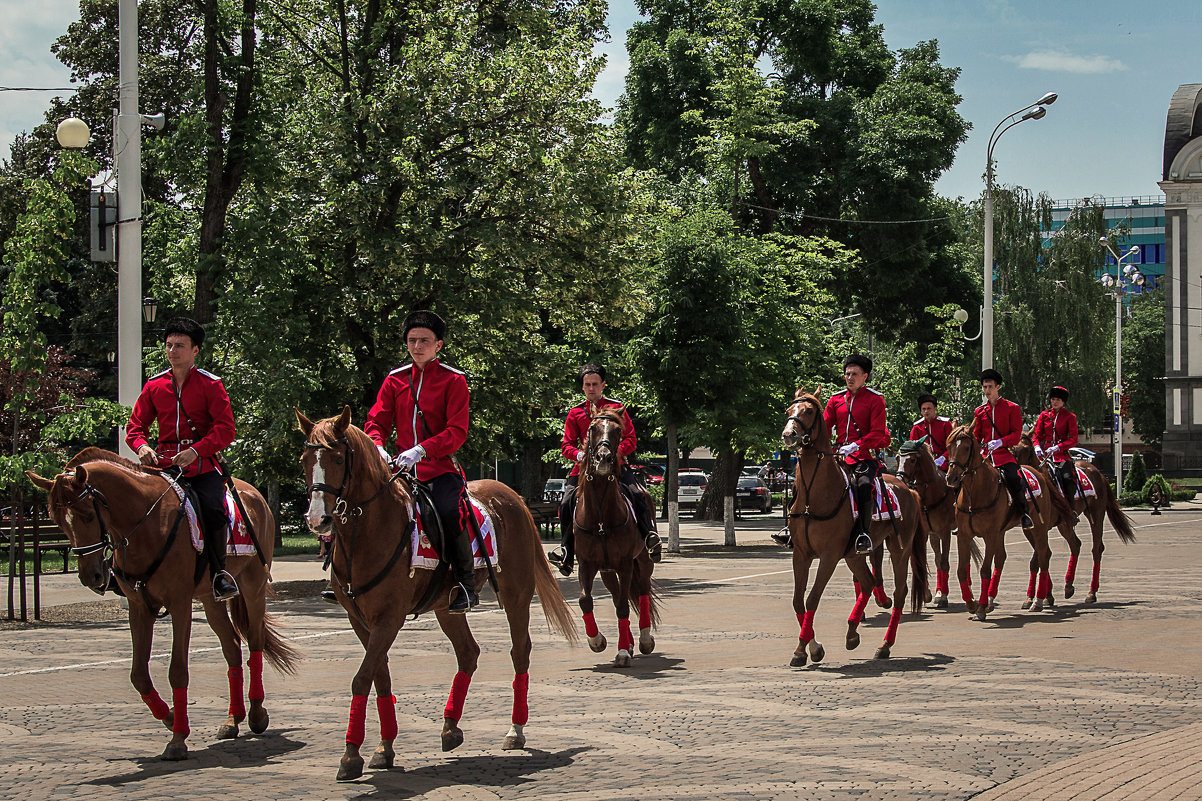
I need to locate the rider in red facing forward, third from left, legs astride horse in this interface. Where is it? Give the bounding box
[547,363,661,576]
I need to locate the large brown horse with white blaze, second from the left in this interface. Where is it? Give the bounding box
[296,407,578,781]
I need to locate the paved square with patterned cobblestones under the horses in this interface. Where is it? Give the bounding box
[0,505,1202,801]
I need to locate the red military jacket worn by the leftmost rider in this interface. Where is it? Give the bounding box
[125,367,234,477]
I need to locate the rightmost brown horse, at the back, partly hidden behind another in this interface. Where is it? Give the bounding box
[1013,431,1135,604]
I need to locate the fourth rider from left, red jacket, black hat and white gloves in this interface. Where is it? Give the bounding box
[822,354,889,553]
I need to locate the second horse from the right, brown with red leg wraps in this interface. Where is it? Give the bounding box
[947,426,1067,621]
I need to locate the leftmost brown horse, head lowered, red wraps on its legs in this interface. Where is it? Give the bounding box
[26,447,298,760]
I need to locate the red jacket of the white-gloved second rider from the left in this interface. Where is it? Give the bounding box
[363,358,469,481]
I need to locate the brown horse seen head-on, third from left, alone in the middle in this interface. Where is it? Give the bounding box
[572,408,659,668]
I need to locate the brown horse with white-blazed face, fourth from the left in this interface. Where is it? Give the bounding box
[780,388,927,668]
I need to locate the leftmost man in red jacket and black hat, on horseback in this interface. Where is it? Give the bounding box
[125,318,238,600]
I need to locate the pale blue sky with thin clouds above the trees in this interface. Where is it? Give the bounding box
[7,0,1202,200]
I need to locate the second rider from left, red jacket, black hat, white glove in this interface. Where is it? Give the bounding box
[363,309,480,613]
